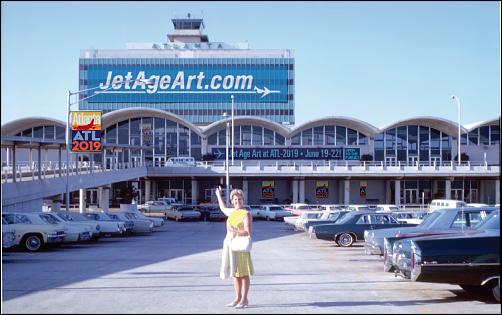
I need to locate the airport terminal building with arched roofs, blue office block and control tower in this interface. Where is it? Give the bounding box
[2,17,500,209]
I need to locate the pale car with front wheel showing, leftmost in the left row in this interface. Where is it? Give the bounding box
[2,213,65,252]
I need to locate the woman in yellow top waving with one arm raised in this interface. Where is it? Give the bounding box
[216,186,254,308]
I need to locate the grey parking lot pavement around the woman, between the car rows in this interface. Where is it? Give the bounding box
[2,221,500,314]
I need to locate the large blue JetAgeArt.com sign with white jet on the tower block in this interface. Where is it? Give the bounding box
[86,61,289,103]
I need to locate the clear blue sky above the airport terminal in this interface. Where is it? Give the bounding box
[1,1,501,127]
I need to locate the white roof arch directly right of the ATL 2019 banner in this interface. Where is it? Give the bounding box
[102,107,202,136]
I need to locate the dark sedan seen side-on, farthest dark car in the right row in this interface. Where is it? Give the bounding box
[313,210,416,247]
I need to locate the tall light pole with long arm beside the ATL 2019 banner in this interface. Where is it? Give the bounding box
[66,79,155,211]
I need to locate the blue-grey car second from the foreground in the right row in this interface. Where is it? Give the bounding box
[383,207,496,278]
